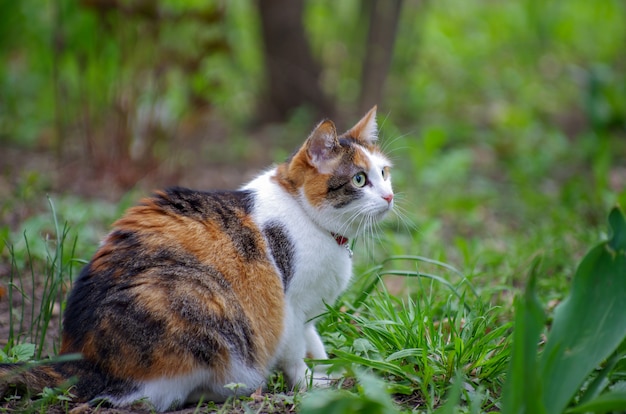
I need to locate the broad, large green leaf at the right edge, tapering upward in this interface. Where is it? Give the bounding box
[539,207,626,413]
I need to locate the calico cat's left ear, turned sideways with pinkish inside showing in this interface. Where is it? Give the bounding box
[306,120,339,174]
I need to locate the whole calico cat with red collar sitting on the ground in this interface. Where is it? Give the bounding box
[0,107,394,411]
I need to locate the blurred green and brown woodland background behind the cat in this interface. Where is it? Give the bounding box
[0,0,626,291]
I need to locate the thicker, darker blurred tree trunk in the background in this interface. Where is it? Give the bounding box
[257,0,335,122]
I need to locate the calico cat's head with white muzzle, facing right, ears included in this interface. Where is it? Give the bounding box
[276,107,393,237]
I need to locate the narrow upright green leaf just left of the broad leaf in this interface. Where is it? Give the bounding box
[502,259,546,414]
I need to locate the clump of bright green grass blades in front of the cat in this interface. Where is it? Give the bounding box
[320,256,511,411]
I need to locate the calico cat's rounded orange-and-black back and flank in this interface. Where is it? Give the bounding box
[62,188,284,408]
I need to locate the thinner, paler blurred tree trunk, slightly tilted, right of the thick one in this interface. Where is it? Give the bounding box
[359,0,402,113]
